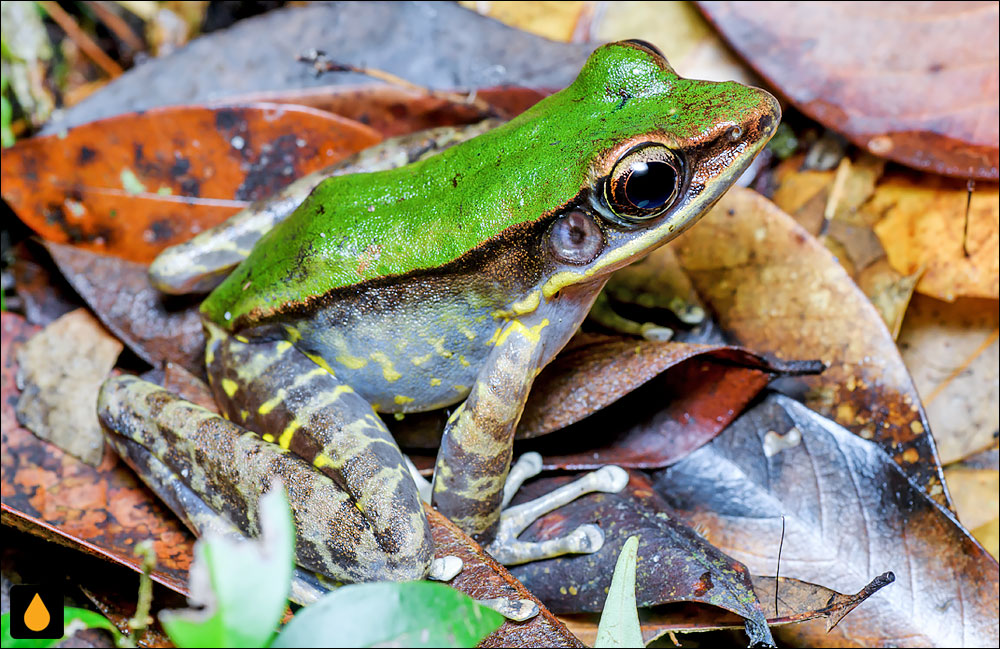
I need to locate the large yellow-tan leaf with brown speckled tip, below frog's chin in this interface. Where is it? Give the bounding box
[671,188,947,504]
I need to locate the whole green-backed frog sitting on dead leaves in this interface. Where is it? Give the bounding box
[98,40,781,582]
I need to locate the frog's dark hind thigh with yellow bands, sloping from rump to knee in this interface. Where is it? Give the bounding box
[206,324,433,570]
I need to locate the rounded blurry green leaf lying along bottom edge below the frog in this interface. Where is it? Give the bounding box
[271,581,503,648]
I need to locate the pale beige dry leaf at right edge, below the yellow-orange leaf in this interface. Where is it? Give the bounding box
[899,295,1000,464]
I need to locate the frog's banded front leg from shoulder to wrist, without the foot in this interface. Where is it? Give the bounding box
[433,320,548,544]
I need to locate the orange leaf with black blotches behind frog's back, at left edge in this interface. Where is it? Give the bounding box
[2,104,381,263]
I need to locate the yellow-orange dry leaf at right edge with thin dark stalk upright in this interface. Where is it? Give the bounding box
[864,174,1000,302]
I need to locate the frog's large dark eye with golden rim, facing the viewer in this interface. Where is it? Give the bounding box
[604,144,681,221]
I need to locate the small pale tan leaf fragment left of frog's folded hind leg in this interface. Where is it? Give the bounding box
[16,309,122,466]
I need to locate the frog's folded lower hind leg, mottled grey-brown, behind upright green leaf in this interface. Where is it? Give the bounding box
[98,376,431,582]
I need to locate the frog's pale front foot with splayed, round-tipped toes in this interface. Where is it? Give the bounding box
[486,453,628,566]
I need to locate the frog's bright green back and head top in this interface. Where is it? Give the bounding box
[202,42,757,325]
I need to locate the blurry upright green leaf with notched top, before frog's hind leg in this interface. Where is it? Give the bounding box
[160,487,294,647]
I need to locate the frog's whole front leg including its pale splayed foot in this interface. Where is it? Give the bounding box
[432,317,628,563]
